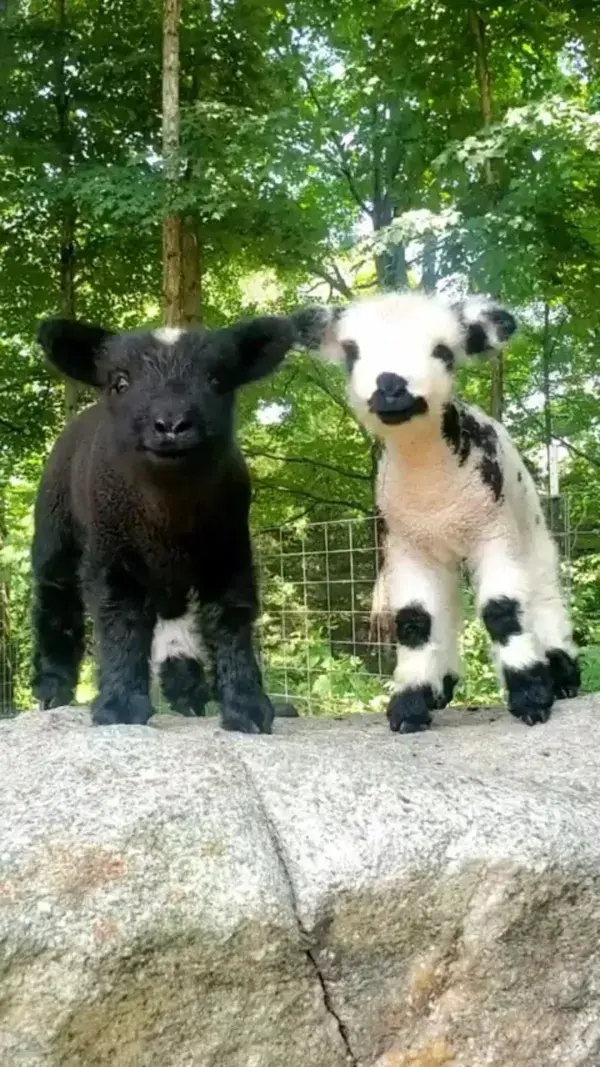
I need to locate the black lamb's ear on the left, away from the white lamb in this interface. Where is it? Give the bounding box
[36,319,113,387]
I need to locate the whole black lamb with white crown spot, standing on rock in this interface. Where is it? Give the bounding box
[32,317,295,733]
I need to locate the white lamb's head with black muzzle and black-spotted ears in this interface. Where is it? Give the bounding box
[298,292,516,434]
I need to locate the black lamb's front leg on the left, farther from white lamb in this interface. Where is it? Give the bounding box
[84,561,156,726]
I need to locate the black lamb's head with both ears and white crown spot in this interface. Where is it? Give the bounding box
[38,317,295,471]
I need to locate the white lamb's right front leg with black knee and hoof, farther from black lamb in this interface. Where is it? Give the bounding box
[471,534,553,726]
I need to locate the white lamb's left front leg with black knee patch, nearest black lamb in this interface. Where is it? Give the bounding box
[385,538,457,733]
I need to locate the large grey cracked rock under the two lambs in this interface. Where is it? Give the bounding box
[0,697,600,1067]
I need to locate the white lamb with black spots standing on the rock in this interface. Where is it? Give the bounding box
[295,292,580,733]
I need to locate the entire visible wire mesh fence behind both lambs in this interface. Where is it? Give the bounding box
[0,497,600,716]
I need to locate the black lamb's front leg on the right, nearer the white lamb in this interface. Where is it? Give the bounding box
[202,575,274,733]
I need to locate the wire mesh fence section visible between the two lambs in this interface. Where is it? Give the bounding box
[255,516,394,712]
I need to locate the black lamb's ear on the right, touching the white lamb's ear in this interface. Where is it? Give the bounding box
[218,315,296,389]
